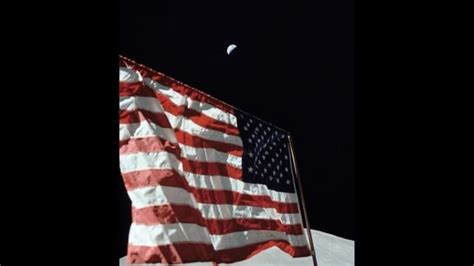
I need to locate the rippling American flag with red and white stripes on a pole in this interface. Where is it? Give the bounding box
[119,56,310,264]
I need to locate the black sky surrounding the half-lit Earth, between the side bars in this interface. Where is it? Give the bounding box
[119,0,354,254]
